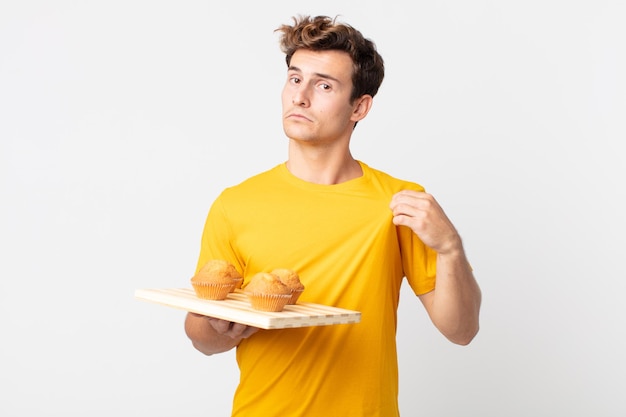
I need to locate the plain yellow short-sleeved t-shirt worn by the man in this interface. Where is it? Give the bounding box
[198,163,436,417]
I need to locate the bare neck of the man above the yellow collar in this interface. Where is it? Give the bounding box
[287,141,363,185]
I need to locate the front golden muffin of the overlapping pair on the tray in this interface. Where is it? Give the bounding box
[244,272,291,311]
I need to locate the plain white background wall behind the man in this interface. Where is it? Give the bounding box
[0,0,626,417]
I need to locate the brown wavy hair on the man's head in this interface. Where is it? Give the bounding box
[276,16,385,101]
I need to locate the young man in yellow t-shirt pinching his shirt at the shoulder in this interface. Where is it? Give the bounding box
[185,17,481,417]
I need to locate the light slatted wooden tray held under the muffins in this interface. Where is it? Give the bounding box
[135,288,361,329]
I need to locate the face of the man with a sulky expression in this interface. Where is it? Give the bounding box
[282,49,358,144]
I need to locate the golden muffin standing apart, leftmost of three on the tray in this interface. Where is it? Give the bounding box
[191,259,241,300]
